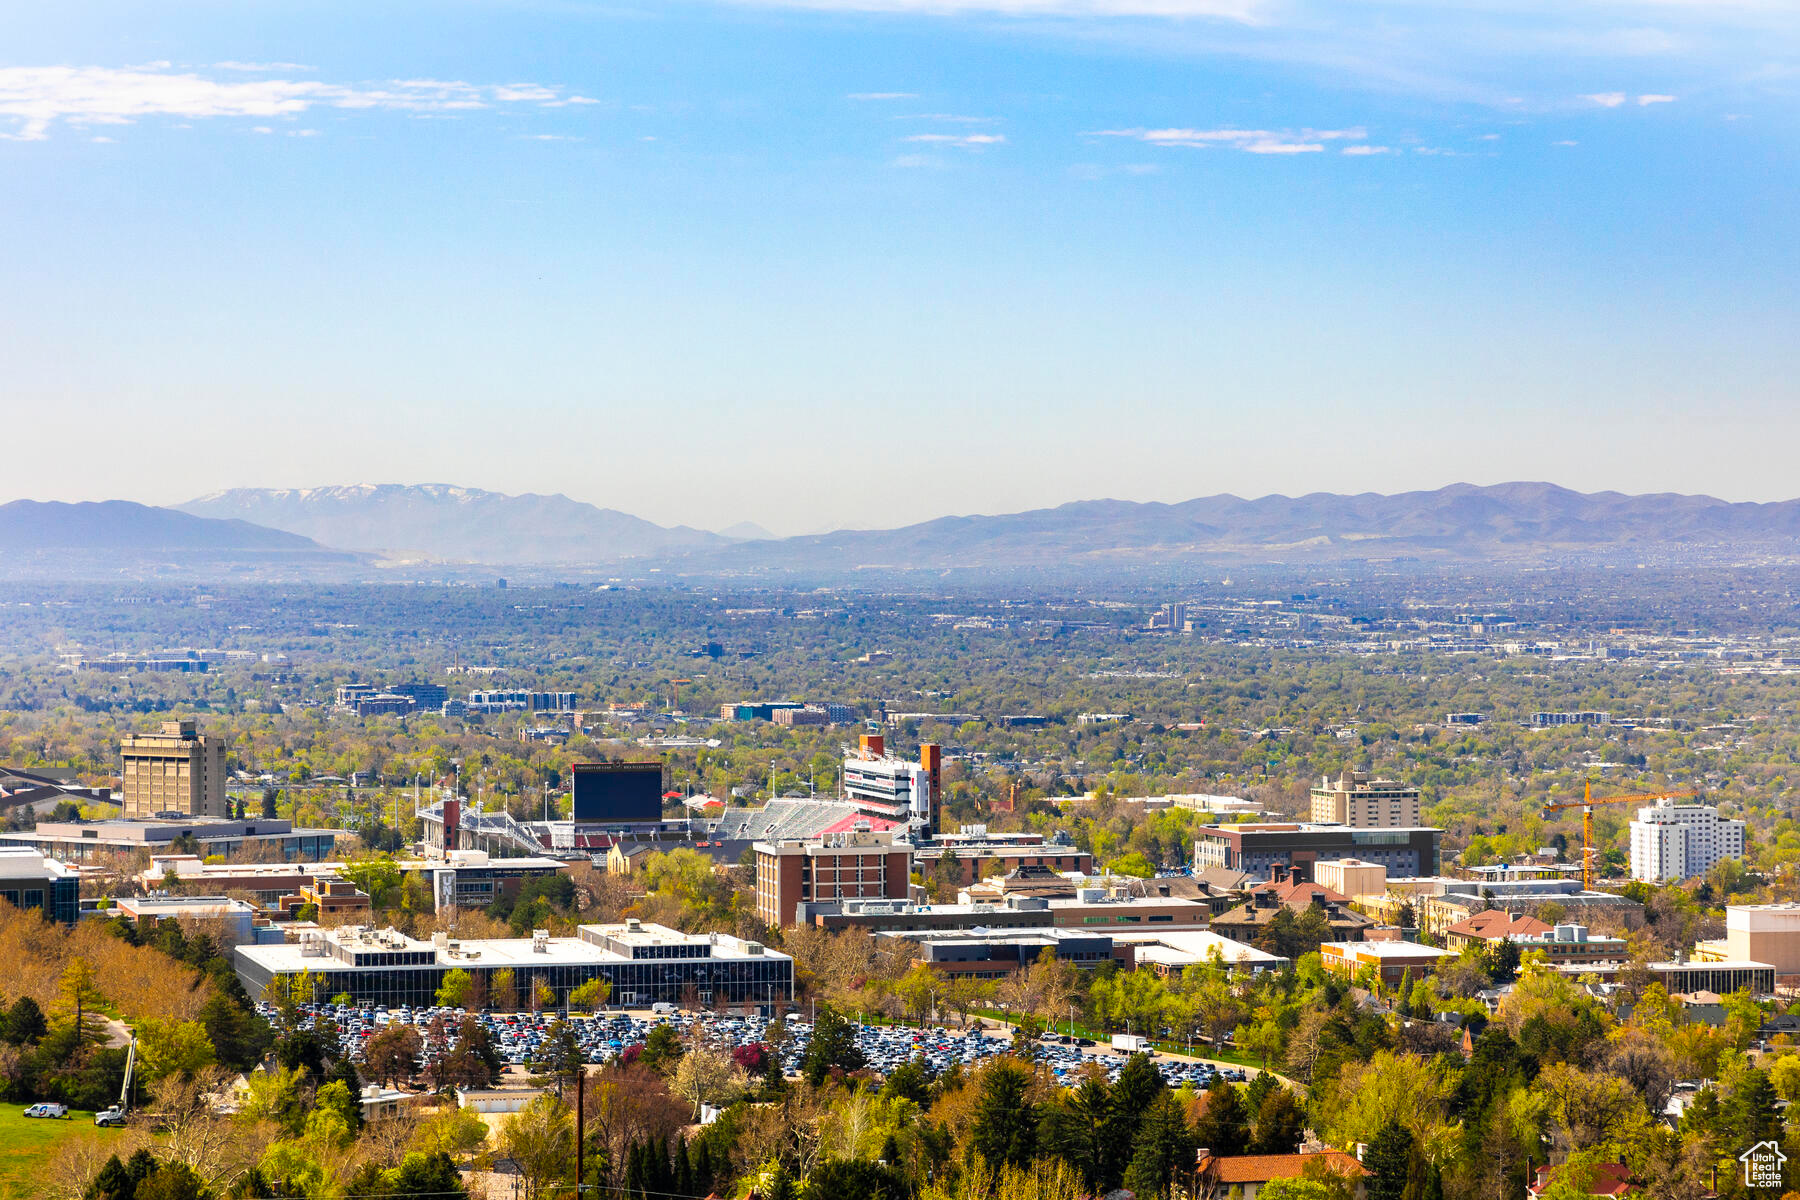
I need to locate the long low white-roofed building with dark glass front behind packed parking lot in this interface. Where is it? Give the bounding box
[236,919,794,1016]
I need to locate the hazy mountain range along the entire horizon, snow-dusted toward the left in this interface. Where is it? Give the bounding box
[10,484,1800,578]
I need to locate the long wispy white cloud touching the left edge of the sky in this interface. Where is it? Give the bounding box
[0,63,596,142]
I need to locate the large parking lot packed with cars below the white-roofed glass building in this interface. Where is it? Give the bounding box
[263,1004,1246,1088]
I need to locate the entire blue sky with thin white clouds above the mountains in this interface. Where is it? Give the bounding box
[0,0,1800,533]
